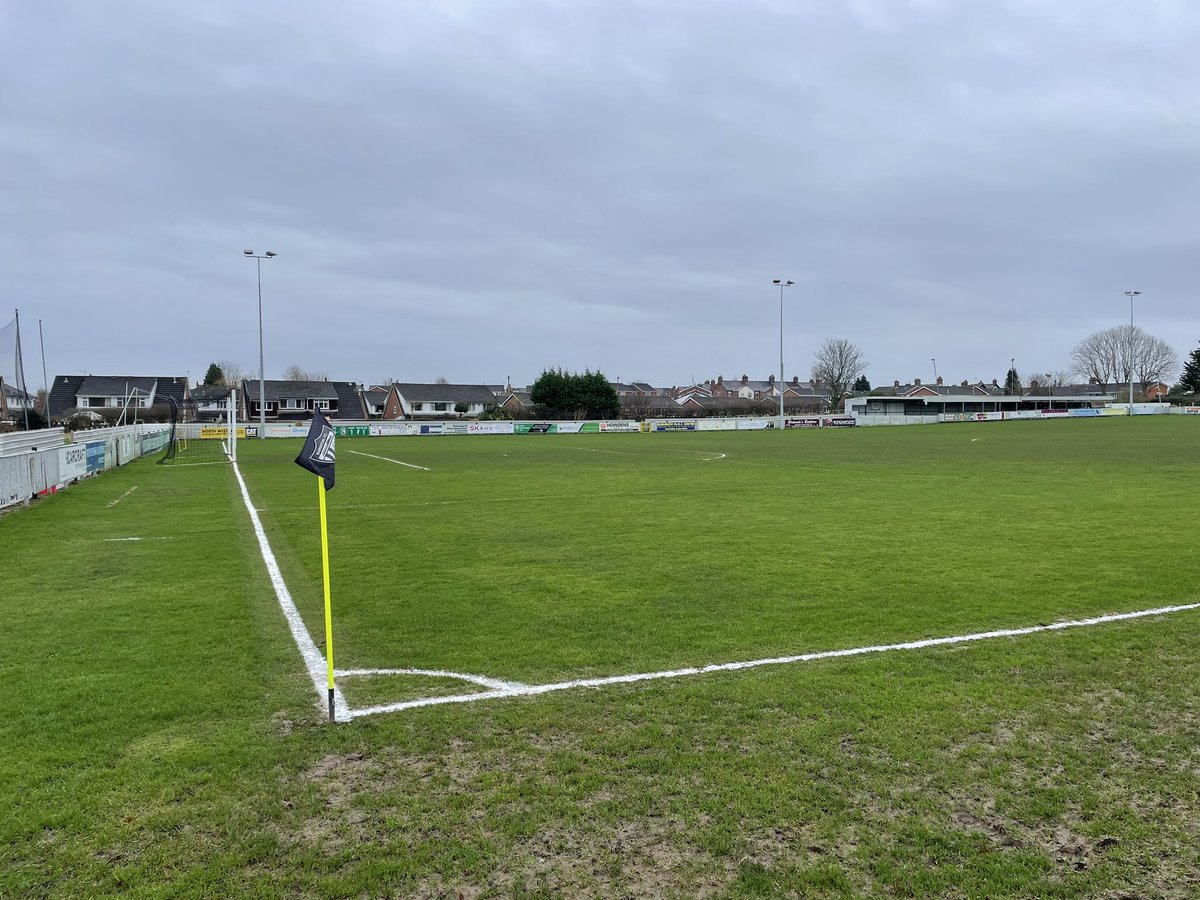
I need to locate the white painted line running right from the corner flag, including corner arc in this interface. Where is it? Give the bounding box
[349,604,1200,719]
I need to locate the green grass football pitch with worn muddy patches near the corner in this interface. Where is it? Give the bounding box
[0,416,1200,896]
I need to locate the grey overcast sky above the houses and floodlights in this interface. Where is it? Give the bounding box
[0,0,1200,386]
